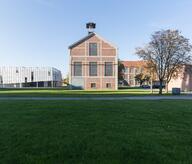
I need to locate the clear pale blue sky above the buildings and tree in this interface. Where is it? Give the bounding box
[0,0,192,75]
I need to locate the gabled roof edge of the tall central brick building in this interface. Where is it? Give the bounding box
[69,32,117,49]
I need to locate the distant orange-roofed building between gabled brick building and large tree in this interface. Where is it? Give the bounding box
[122,60,148,87]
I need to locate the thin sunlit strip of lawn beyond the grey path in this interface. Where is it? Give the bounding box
[0,89,166,97]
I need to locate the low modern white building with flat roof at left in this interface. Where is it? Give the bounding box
[0,67,62,88]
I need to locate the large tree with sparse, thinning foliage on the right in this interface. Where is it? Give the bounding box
[136,30,192,94]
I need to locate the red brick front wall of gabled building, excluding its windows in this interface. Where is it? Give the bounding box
[70,36,118,90]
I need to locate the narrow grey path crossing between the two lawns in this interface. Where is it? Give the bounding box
[0,95,192,101]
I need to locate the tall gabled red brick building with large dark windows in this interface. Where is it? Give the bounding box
[69,32,118,90]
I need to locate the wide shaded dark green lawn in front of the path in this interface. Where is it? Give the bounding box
[0,100,192,164]
